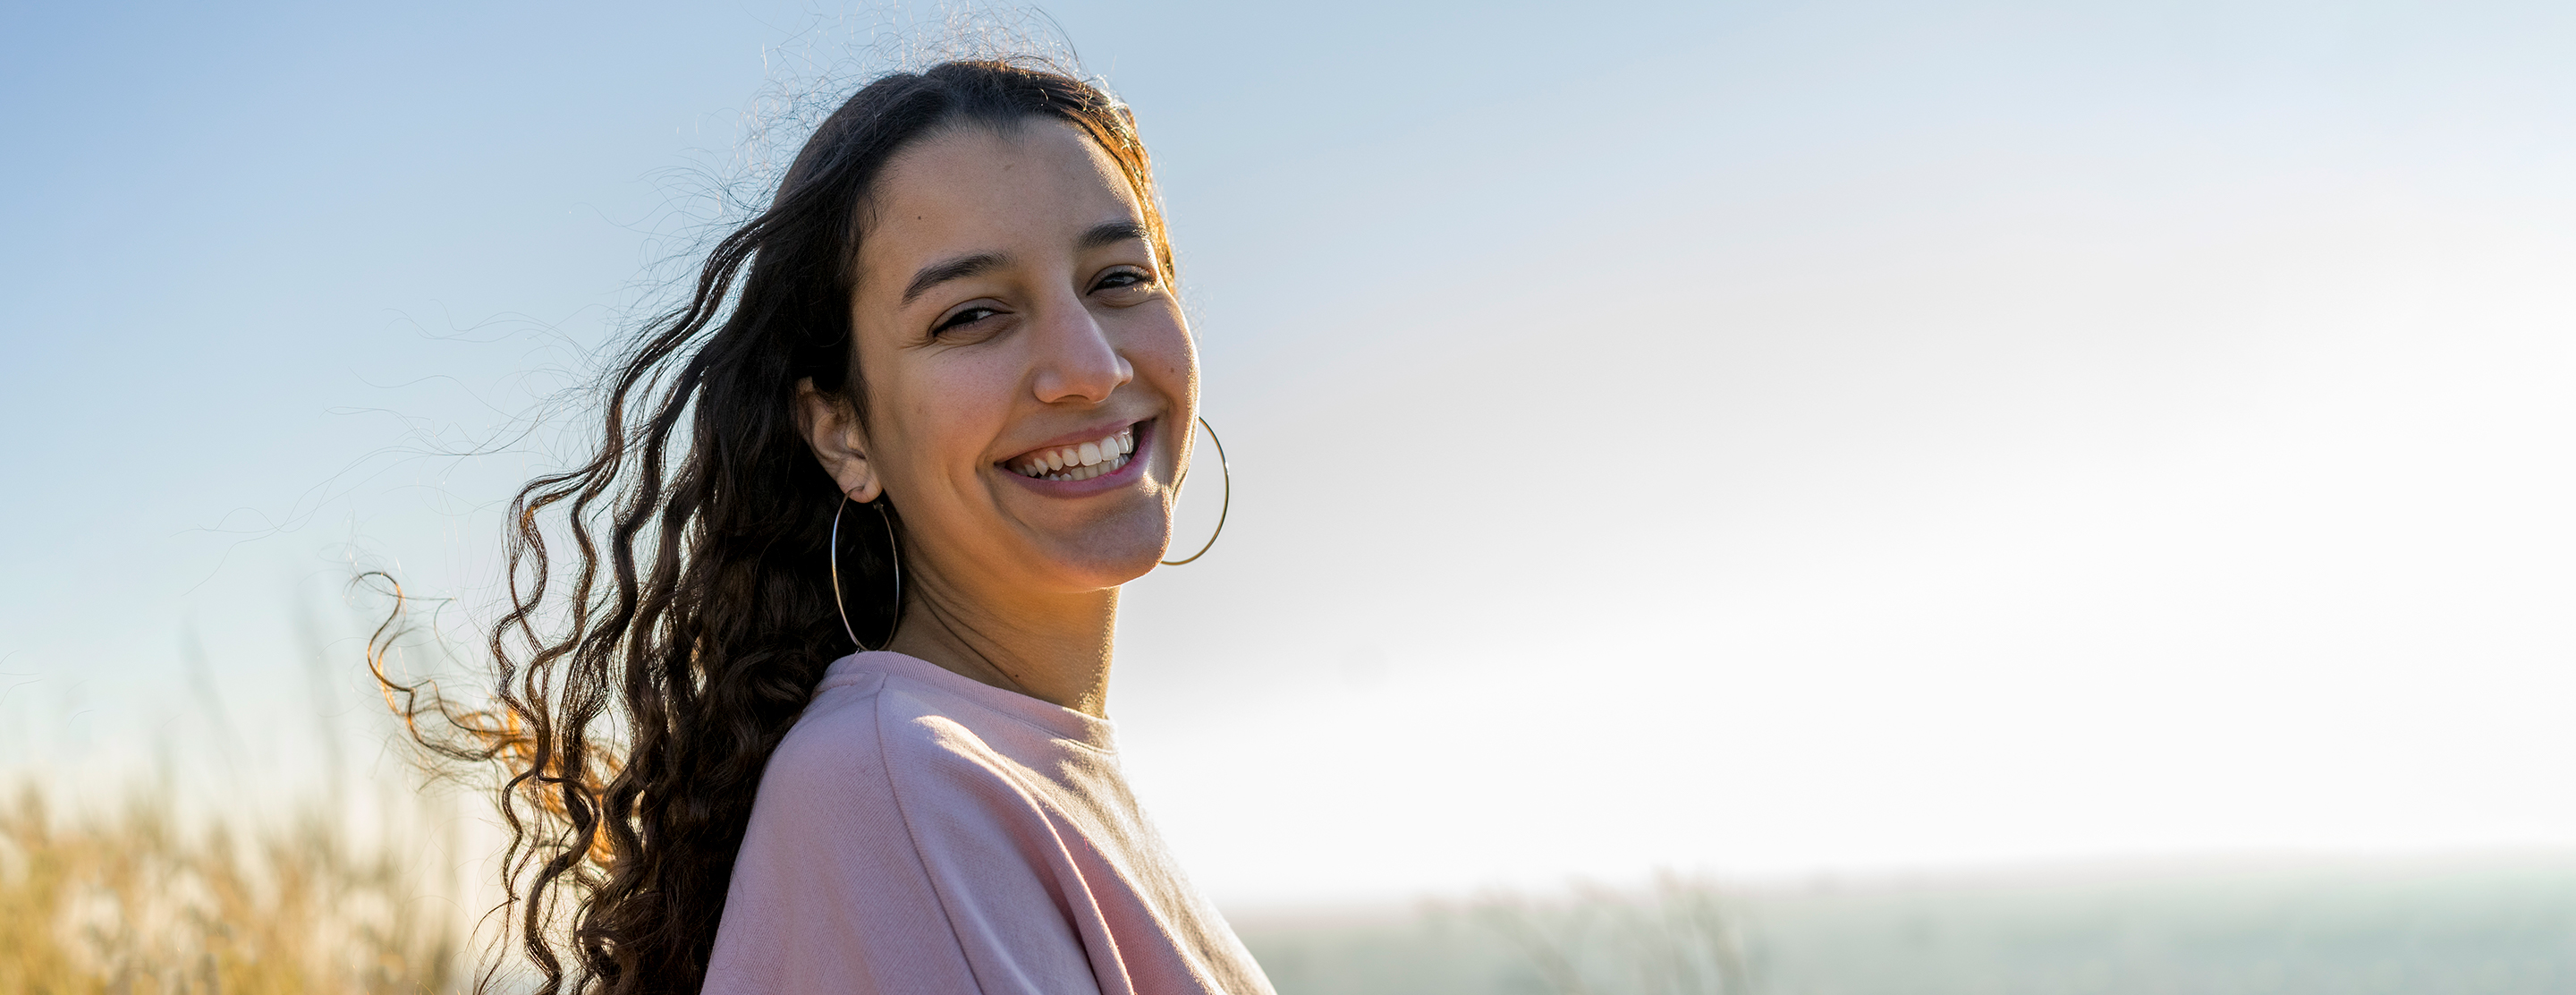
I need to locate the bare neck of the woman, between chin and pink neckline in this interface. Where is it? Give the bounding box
[886,577,1118,717]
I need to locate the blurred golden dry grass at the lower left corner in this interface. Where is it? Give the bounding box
[0,789,462,995]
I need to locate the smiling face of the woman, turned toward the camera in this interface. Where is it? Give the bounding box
[809,119,1198,593]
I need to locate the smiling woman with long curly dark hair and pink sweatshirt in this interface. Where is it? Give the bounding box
[407,62,1270,995]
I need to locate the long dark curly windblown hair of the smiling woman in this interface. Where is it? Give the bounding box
[371,59,1172,995]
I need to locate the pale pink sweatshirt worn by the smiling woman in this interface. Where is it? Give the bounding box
[703,652,1270,995]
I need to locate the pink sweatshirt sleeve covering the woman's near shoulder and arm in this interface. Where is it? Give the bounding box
[703,688,1100,995]
